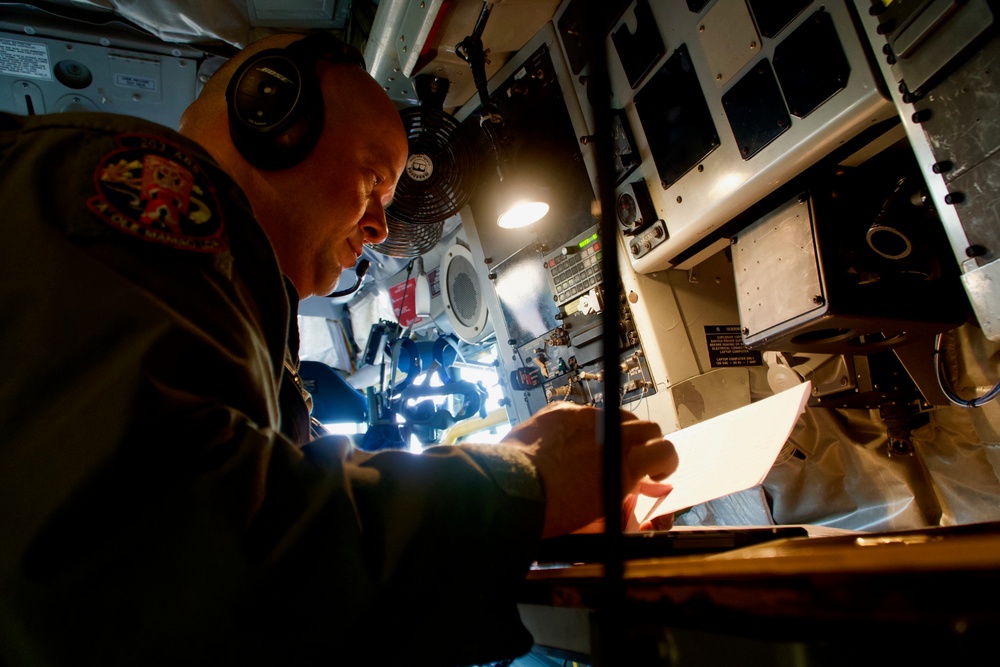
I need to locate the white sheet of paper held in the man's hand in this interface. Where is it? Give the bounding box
[626,382,812,530]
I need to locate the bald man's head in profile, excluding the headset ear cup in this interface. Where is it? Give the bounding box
[180,35,408,298]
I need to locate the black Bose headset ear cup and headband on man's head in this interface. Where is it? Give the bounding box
[226,32,366,170]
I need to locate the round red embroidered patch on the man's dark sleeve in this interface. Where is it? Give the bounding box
[87,135,229,253]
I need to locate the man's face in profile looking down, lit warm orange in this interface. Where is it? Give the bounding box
[258,64,408,298]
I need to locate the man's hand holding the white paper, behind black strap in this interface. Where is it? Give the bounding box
[504,402,677,537]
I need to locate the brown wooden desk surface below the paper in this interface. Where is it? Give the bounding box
[522,523,1000,639]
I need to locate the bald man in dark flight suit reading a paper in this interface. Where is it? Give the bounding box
[0,35,676,665]
